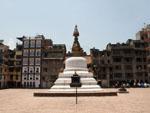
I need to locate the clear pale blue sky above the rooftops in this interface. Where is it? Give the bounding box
[0,0,150,53]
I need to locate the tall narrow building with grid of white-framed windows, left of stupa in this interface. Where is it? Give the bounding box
[20,35,44,88]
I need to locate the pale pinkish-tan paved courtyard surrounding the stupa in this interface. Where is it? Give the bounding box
[0,88,150,113]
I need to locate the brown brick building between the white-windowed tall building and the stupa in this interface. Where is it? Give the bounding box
[41,43,66,88]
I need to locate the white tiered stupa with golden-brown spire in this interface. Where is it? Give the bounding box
[49,26,101,93]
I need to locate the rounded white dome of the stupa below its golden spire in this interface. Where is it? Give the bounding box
[64,57,88,71]
